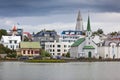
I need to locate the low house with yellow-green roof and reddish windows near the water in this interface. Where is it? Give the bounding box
[18,42,41,56]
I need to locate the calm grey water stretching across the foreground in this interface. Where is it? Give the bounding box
[0,62,120,80]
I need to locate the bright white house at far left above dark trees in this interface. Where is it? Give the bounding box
[1,36,21,50]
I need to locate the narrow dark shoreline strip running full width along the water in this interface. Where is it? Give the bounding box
[0,59,120,63]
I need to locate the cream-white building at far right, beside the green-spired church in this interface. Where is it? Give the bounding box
[98,40,120,59]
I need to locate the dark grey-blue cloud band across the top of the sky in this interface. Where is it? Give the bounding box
[0,0,120,17]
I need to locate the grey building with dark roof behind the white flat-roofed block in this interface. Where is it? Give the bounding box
[33,30,59,49]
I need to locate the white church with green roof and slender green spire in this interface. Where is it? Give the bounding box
[70,16,97,58]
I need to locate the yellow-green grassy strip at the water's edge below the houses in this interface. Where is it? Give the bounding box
[25,59,65,63]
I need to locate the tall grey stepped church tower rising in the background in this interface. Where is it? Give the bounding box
[75,11,83,31]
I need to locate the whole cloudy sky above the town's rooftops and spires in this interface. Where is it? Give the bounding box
[0,0,120,33]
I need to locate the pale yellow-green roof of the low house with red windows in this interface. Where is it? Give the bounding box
[20,42,41,48]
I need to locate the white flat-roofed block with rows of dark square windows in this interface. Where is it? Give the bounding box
[45,41,71,57]
